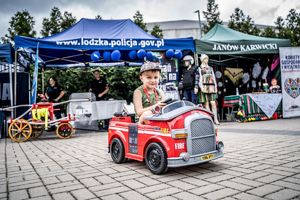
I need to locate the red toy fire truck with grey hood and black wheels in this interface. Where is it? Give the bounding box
[108,101,224,174]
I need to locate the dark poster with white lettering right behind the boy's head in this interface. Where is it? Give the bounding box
[159,59,180,100]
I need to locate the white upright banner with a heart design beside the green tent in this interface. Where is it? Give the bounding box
[279,47,300,118]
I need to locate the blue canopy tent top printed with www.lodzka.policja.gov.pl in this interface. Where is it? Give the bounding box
[14,18,195,67]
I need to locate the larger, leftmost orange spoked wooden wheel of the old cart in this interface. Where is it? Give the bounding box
[8,119,32,142]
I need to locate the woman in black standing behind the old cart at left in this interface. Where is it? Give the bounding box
[45,77,65,119]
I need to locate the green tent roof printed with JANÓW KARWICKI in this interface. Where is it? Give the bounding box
[196,24,291,55]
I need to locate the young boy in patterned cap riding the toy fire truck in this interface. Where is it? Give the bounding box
[133,62,165,124]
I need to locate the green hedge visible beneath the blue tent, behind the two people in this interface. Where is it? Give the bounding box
[38,67,142,102]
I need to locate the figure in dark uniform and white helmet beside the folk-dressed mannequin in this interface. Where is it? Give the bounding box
[182,55,198,104]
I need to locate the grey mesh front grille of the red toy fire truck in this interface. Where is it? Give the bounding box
[187,118,216,155]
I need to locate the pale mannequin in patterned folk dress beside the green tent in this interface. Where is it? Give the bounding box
[195,54,220,125]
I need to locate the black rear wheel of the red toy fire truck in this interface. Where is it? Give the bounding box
[110,138,125,164]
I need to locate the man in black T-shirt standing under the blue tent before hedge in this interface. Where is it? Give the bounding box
[90,69,109,101]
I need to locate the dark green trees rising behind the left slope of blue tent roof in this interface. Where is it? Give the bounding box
[41,7,76,37]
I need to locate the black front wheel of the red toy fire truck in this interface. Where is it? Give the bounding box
[145,142,168,174]
